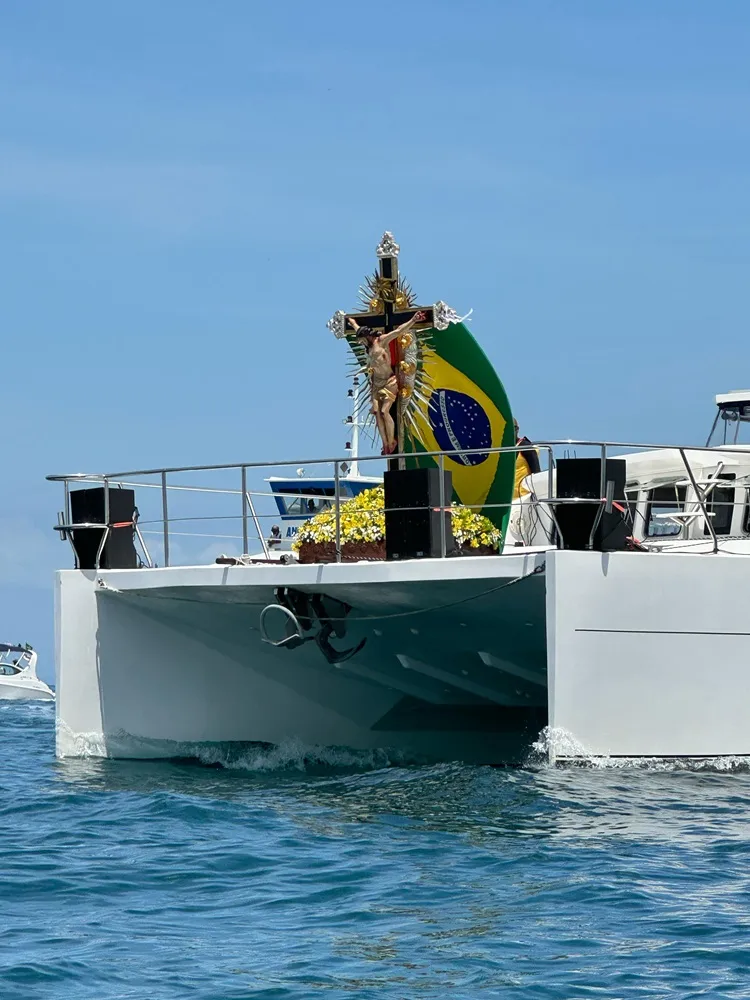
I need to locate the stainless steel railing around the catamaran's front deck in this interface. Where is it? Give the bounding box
[47,439,750,566]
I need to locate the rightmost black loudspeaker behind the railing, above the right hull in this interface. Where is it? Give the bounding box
[555,458,633,552]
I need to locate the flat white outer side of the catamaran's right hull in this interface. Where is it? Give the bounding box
[547,552,750,759]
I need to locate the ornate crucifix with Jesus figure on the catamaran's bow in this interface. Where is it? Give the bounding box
[328,233,435,469]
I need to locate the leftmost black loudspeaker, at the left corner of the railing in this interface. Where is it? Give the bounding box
[70,486,138,569]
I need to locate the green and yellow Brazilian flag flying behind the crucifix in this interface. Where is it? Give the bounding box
[404,323,516,537]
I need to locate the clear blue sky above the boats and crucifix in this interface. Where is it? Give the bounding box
[0,0,750,677]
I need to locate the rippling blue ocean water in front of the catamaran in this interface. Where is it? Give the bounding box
[0,703,750,1000]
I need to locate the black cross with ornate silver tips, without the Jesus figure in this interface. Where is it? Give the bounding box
[328,232,435,469]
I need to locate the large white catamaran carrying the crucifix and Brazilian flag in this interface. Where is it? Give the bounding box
[49,234,750,763]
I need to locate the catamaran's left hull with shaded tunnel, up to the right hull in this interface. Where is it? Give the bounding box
[56,556,547,760]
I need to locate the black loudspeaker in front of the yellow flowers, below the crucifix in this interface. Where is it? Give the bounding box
[383,469,454,559]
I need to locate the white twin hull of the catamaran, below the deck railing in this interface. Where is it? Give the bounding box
[57,551,750,764]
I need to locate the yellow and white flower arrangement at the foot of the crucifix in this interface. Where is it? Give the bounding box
[292,486,501,561]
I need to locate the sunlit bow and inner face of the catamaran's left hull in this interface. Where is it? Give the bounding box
[57,573,402,757]
